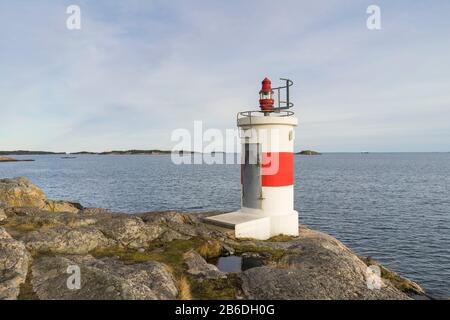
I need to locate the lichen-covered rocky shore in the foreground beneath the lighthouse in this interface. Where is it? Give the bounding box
[0,178,425,300]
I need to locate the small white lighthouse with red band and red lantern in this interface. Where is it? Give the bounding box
[205,78,298,240]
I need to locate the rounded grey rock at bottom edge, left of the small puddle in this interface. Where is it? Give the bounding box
[32,255,178,300]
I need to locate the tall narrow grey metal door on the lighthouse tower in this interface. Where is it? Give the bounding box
[242,143,262,209]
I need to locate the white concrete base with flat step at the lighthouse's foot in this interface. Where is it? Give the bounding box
[205,210,298,240]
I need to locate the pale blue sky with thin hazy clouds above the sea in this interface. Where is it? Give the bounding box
[0,0,450,152]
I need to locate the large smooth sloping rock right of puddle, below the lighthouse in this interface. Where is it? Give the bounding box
[241,228,409,299]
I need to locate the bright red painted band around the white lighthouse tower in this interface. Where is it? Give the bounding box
[261,152,294,187]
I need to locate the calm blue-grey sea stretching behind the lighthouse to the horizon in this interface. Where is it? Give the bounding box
[0,153,450,297]
